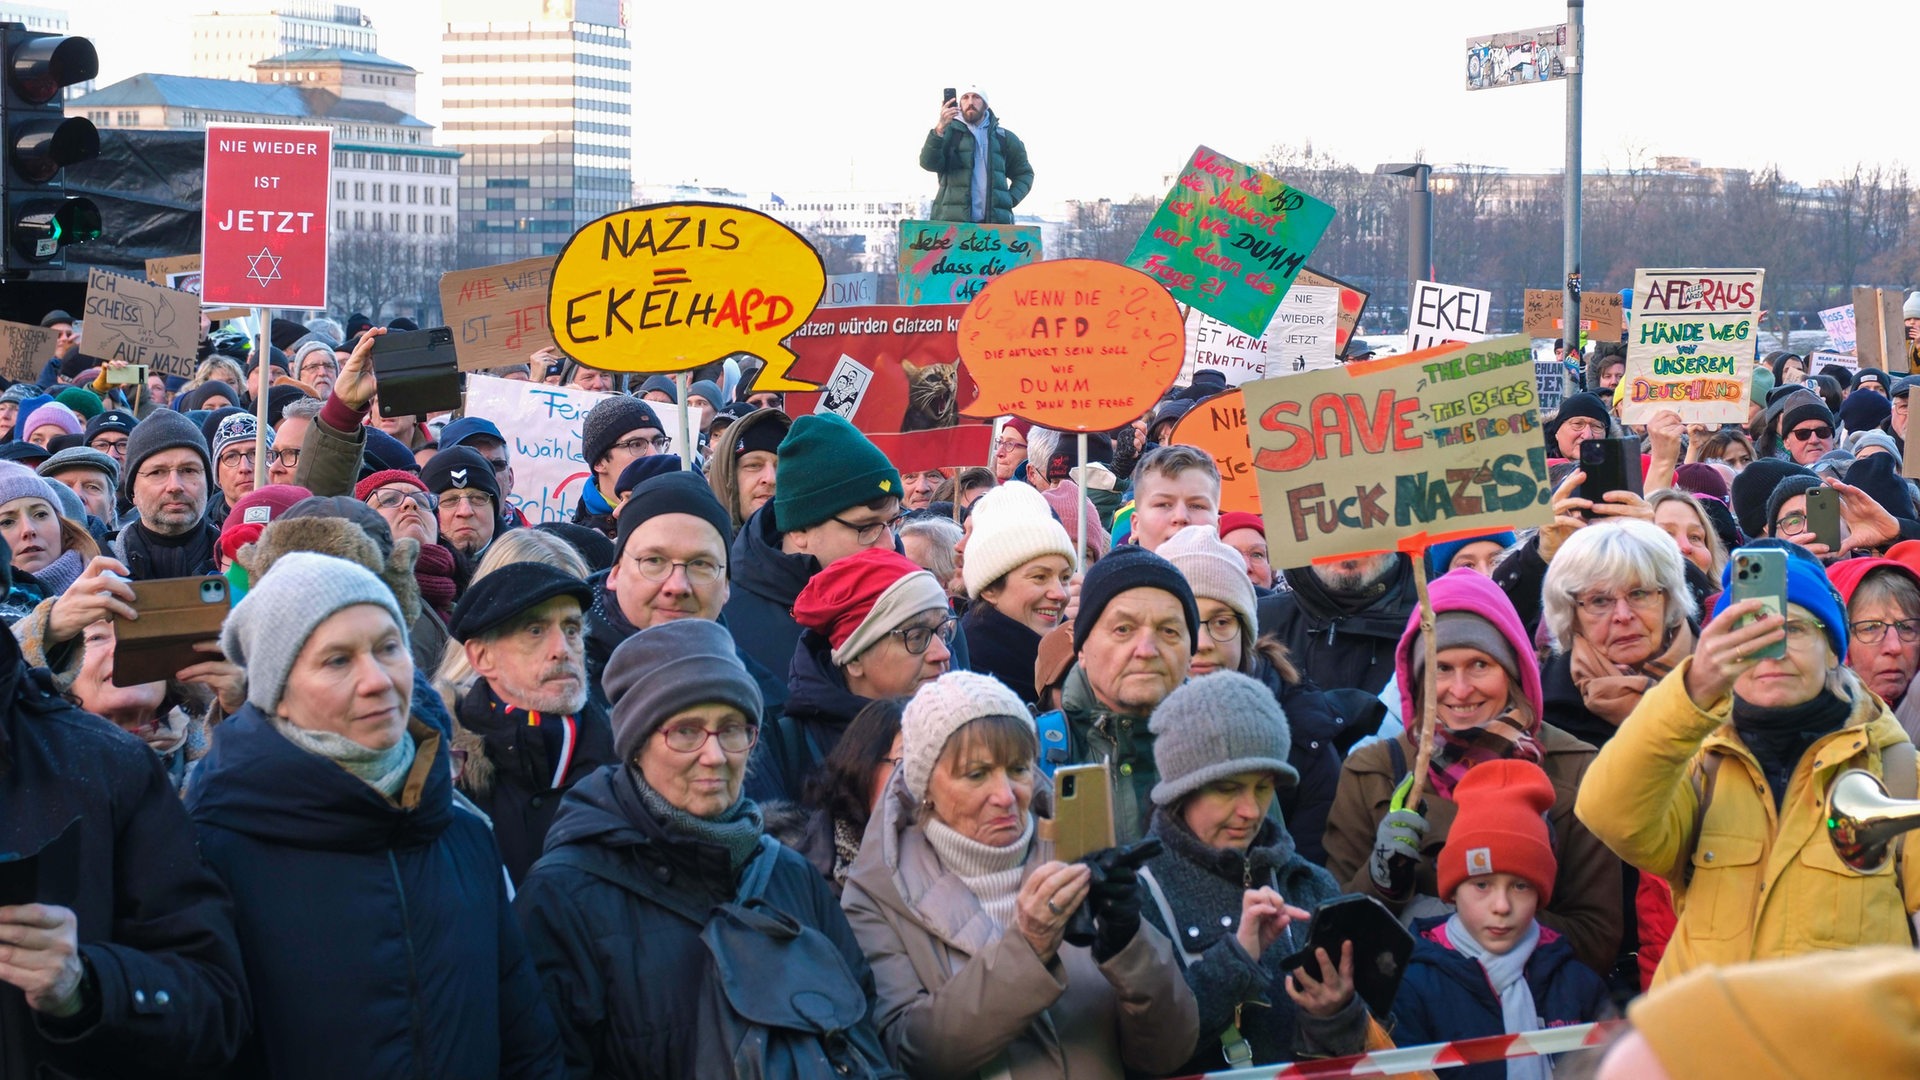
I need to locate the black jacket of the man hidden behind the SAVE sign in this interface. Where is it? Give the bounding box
[1254,555,1419,694]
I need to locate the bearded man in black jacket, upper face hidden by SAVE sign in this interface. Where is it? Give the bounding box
[1256,553,1419,696]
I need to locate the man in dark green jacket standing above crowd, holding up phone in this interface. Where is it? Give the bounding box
[920,86,1033,225]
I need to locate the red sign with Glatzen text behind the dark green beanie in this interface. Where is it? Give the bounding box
[787,304,993,473]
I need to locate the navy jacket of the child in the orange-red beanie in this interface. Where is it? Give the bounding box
[1392,915,1615,1080]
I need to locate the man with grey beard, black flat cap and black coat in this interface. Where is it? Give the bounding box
[434,563,614,888]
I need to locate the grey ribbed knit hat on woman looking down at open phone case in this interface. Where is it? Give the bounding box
[1146,671,1300,807]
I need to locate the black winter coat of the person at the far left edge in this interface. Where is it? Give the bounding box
[0,634,250,1080]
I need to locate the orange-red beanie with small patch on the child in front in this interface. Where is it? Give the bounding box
[1436,759,1559,907]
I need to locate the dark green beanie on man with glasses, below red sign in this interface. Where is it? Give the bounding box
[774,413,900,532]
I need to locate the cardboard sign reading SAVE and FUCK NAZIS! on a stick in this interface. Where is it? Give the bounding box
[1240,334,1553,553]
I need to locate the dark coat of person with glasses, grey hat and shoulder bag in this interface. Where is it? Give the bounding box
[515,765,874,1080]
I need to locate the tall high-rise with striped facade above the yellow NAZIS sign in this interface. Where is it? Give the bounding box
[440,0,634,265]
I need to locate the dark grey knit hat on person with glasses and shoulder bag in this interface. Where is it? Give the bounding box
[601,619,766,761]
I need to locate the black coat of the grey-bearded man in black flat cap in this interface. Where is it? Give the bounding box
[459,680,618,886]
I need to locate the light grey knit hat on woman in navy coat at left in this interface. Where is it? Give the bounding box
[221,552,407,715]
